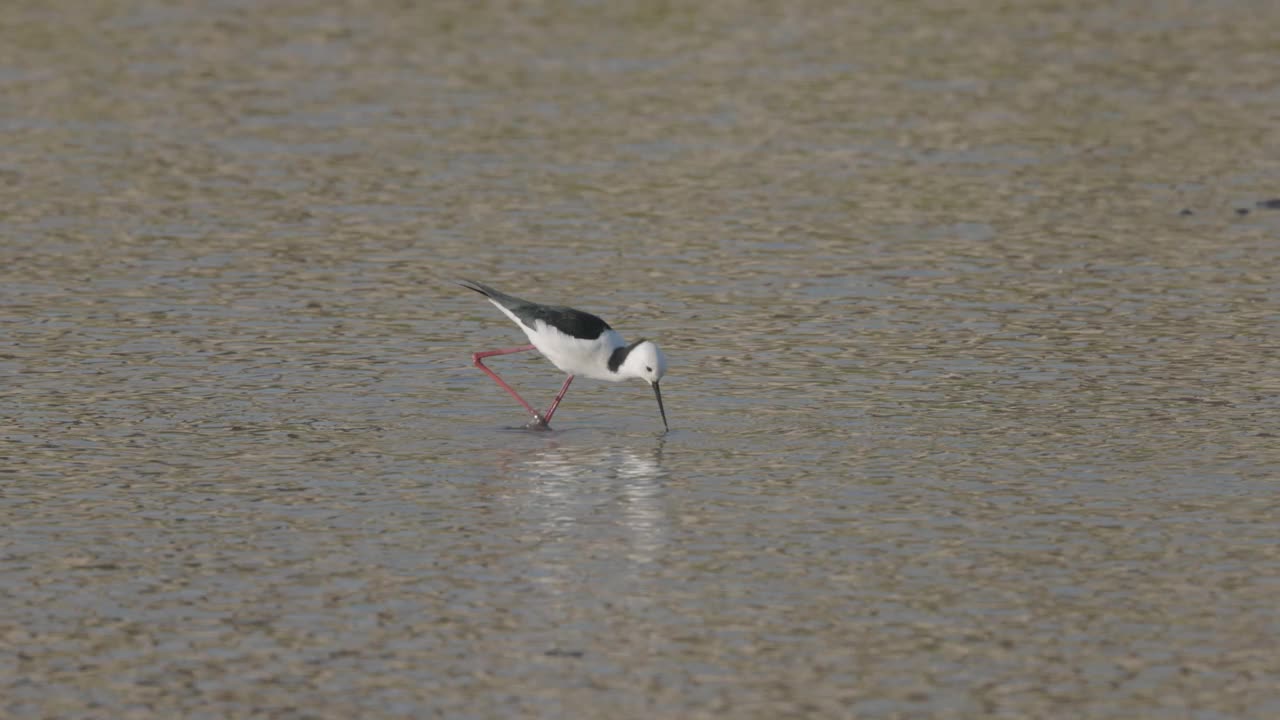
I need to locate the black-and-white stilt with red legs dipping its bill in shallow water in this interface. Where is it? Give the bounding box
[458,281,669,429]
